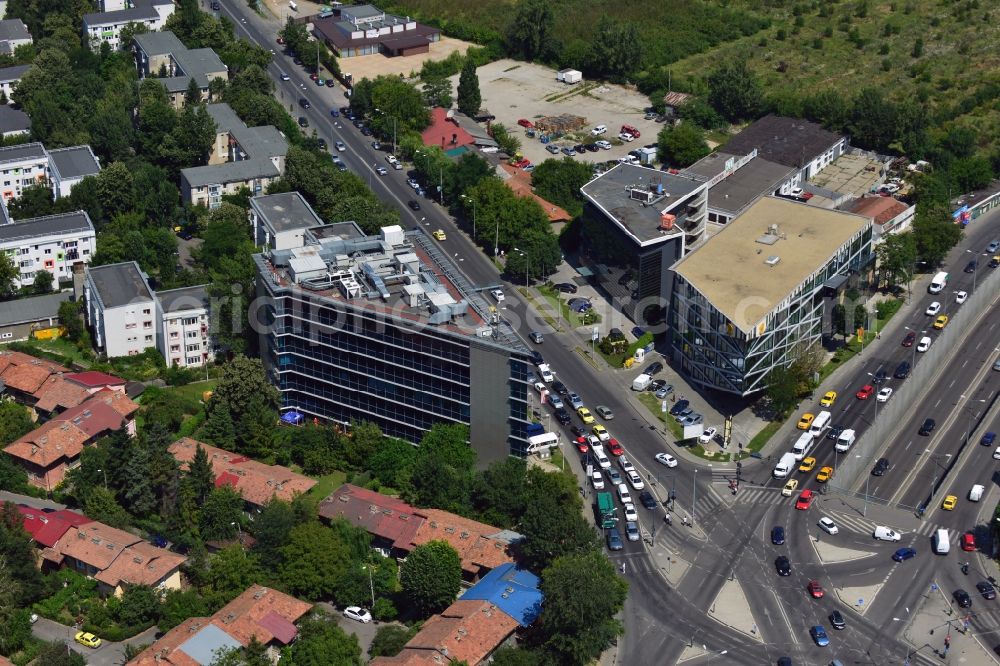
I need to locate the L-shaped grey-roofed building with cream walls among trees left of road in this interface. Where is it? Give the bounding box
[181,104,288,208]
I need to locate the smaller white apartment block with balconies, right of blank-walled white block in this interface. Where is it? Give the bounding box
[156,284,215,368]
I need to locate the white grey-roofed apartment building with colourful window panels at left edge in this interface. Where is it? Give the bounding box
[0,210,97,289]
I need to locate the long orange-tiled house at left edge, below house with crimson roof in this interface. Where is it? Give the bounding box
[4,389,139,491]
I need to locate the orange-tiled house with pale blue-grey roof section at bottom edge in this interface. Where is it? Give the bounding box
[128,585,312,666]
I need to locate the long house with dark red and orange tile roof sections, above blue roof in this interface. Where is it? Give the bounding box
[319,484,521,581]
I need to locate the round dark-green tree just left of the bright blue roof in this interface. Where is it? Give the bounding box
[399,541,462,617]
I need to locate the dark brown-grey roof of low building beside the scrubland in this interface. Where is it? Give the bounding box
[723,114,843,167]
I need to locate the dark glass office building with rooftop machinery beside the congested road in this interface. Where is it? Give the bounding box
[251,218,529,465]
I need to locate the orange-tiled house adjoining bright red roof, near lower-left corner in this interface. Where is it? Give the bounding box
[42,522,187,596]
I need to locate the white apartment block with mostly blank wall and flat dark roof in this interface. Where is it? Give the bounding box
[83,261,156,358]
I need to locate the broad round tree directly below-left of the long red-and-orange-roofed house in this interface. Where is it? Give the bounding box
[277,521,353,600]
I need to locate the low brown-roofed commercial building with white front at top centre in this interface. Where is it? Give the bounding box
[312,5,441,58]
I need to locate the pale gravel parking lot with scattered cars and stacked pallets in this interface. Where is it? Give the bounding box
[453,60,663,164]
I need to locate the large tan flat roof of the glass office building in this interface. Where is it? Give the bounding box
[673,197,869,332]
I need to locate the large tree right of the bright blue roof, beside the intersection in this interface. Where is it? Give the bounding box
[536,548,628,666]
